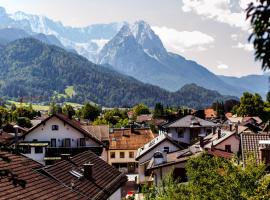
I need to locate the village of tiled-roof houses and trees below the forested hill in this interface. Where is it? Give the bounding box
[0,95,270,200]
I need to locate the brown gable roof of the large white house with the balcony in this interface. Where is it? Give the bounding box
[24,114,104,146]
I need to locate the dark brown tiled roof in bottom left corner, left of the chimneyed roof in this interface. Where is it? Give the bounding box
[0,151,85,200]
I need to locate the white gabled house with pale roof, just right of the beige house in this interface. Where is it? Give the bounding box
[136,134,183,183]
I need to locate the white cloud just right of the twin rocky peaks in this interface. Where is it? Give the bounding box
[152,26,215,53]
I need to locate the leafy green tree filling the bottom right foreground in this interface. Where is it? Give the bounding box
[144,153,270,200]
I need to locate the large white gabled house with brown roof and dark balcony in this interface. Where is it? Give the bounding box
[18,114,107,164]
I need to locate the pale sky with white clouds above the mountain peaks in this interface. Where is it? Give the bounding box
[0,0,262,76]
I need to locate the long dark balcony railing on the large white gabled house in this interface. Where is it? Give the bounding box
[45,147,103,157]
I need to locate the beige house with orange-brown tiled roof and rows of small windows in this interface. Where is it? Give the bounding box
[108,128,155,173]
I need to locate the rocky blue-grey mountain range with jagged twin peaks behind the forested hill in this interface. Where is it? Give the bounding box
[0,8,268,99]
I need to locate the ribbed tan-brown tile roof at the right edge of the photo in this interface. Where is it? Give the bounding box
[241,133,270,163]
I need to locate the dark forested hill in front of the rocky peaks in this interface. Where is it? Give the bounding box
[0,38,234,108]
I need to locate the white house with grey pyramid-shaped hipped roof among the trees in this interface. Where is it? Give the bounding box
[163,115,217,144]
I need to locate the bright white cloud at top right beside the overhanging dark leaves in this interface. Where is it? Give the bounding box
[182,0,251,30]
